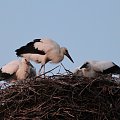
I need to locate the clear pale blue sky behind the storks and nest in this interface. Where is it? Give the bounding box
[0,0,120,74]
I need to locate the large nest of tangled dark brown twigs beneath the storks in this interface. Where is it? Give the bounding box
[0,75,120,120]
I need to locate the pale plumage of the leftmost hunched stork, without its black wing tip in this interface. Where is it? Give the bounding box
[1,58,36,80]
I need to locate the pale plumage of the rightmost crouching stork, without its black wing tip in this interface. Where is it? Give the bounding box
[74,60,119,77]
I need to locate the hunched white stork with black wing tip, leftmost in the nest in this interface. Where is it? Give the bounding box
[0,58,36,81]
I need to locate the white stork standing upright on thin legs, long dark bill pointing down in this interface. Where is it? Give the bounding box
[15,38,74,73]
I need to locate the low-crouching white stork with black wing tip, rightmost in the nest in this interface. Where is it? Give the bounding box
[74,60,120,77]
